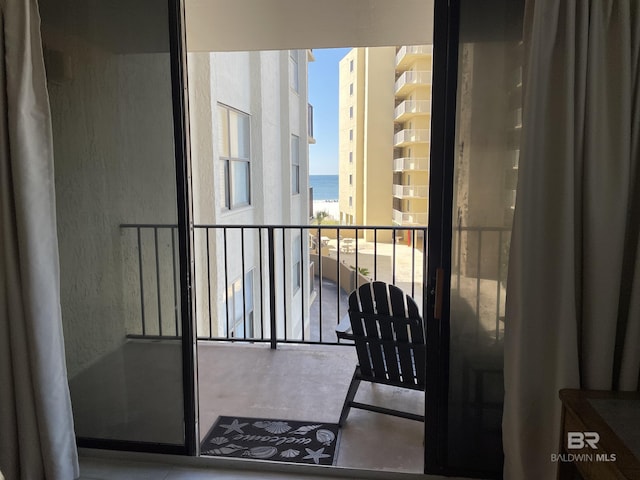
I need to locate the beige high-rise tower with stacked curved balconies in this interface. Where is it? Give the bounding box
[339,46,432,241]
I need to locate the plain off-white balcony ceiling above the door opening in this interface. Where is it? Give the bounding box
[186,0,433,52]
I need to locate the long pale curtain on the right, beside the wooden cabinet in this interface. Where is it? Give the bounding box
[503,0,640,480]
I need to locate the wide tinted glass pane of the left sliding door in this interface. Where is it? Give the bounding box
[40,0,185,445]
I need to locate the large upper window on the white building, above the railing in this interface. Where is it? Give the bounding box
[218,105,251,210]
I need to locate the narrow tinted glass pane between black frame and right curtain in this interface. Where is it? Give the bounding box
[447,0,522,473]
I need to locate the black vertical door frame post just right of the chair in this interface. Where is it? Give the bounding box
[424,0,460,474]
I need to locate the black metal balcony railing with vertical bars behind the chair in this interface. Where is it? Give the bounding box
[121,224,427,348]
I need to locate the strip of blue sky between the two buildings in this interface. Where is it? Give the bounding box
[309,48,351,175]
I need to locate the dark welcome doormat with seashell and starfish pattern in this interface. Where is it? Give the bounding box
[200,417,339,465]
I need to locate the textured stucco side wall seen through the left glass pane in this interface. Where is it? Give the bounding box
[44,31,176,377]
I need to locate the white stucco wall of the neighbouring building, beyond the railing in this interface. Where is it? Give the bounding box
[188,51,308,336]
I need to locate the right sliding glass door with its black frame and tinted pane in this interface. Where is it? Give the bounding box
[426,0,523,477]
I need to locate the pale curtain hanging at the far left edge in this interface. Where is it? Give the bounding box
[0,0,79,480]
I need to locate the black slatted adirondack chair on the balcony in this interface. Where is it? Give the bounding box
[336,282,425,426]
